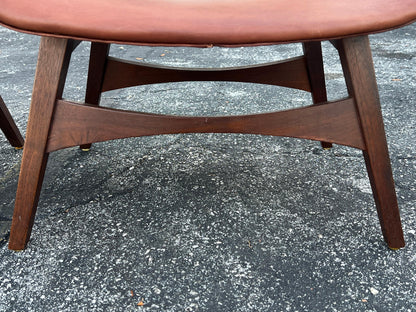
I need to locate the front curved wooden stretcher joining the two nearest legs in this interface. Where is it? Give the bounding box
[47,99,364,152]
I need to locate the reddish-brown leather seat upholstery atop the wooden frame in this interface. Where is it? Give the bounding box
[0,0,416,46]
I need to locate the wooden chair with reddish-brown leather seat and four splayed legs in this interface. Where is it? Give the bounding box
[0,0,416,250]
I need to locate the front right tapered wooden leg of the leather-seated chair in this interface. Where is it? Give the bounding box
[336,36,405,249]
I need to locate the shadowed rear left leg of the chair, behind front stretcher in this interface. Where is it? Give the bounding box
[80,42,110,151]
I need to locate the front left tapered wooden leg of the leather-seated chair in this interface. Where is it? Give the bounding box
[9,37,72,250]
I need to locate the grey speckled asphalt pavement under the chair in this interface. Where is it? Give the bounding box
[0,24,416,312]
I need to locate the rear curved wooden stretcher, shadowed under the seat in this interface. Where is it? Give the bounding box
[103,56,311,92]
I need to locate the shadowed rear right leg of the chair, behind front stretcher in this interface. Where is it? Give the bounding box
[302,41,332,149]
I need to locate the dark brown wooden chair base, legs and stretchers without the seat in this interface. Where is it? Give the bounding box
[9,36,404,250]
